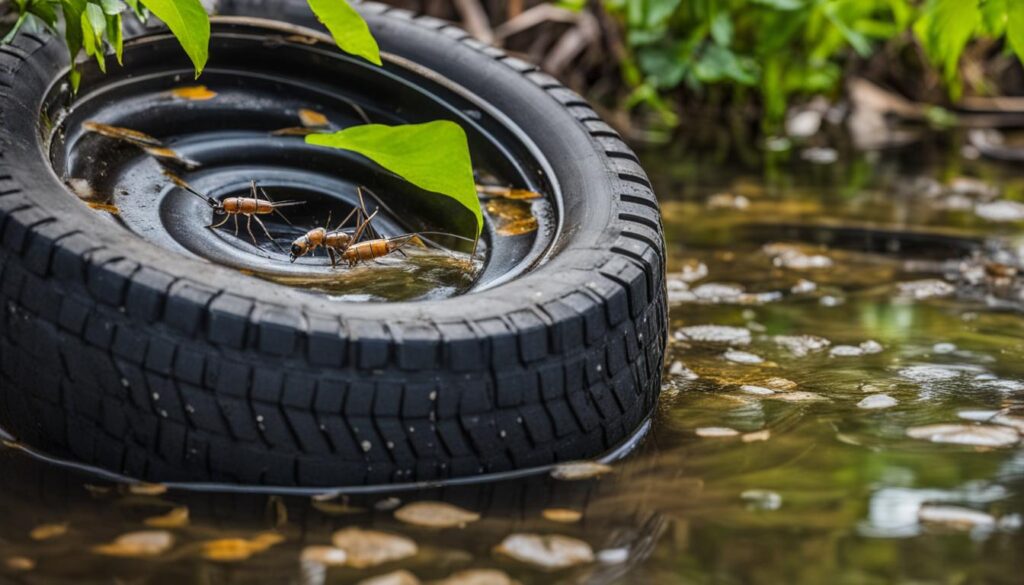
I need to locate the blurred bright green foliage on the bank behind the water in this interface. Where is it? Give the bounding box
[604,0,1024,128]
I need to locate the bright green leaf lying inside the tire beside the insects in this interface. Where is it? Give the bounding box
[306,120,483,237]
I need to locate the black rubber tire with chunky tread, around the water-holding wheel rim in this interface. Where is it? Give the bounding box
[0,0,668,486]
